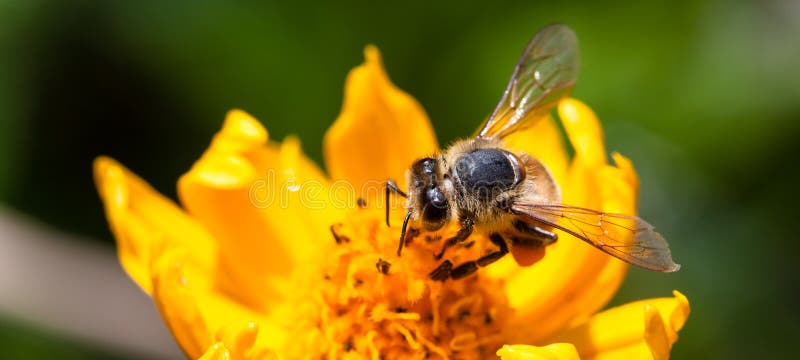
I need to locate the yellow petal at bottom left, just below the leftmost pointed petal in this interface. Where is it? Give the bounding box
[152,250,287,358]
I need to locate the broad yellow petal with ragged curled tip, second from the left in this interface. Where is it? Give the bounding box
[178,111,341,310]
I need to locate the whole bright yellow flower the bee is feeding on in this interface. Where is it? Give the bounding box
[94,47,689,359]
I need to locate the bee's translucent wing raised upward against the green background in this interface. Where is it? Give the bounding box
[477,24,579,138]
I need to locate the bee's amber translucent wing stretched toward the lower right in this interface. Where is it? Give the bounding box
[511,204,680,272]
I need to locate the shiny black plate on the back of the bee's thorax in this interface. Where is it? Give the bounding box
[453,149,525,201]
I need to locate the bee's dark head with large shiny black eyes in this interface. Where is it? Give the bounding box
[411,158,450,231]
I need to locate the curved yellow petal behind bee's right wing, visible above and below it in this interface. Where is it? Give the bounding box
[506,99,638,343]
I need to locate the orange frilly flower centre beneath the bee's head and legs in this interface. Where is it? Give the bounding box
[288,208,512,359]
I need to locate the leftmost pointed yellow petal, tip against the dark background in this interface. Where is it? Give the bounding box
[94,157,216,294]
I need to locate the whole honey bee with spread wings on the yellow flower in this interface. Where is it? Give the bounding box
[386,24,680,281]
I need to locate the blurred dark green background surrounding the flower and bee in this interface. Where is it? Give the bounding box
[0,0,800,359]
